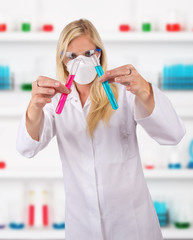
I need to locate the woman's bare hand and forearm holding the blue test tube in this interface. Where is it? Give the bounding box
[99,64,155,114]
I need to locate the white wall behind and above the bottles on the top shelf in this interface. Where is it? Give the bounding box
[0,0,193,32]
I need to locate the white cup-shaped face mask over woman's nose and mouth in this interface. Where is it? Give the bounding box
[66,55,97,84]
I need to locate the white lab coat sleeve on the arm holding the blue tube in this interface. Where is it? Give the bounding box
[133,85,186,145]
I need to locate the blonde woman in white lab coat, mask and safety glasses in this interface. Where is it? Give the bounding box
[17,19,185,240]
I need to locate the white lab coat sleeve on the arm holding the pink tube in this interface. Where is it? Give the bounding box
[16,103,55,158]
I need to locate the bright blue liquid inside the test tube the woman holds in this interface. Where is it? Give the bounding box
[95,65,119,110]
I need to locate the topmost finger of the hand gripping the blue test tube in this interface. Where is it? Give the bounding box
[99,64,134,82]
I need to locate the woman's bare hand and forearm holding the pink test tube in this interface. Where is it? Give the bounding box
[26,77,71,141]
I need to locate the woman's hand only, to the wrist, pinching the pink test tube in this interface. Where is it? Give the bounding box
[30,76,71,109]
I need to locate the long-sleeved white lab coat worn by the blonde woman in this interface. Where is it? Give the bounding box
[17,85,185,240]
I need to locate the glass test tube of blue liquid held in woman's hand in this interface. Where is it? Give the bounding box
[91,54,119,110]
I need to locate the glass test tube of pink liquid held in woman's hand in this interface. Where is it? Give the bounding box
[56,59,81,114]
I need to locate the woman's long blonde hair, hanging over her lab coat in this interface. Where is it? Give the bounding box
[56,19,118,137]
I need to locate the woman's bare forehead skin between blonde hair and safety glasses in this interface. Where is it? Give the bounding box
[64,34,98,65]
